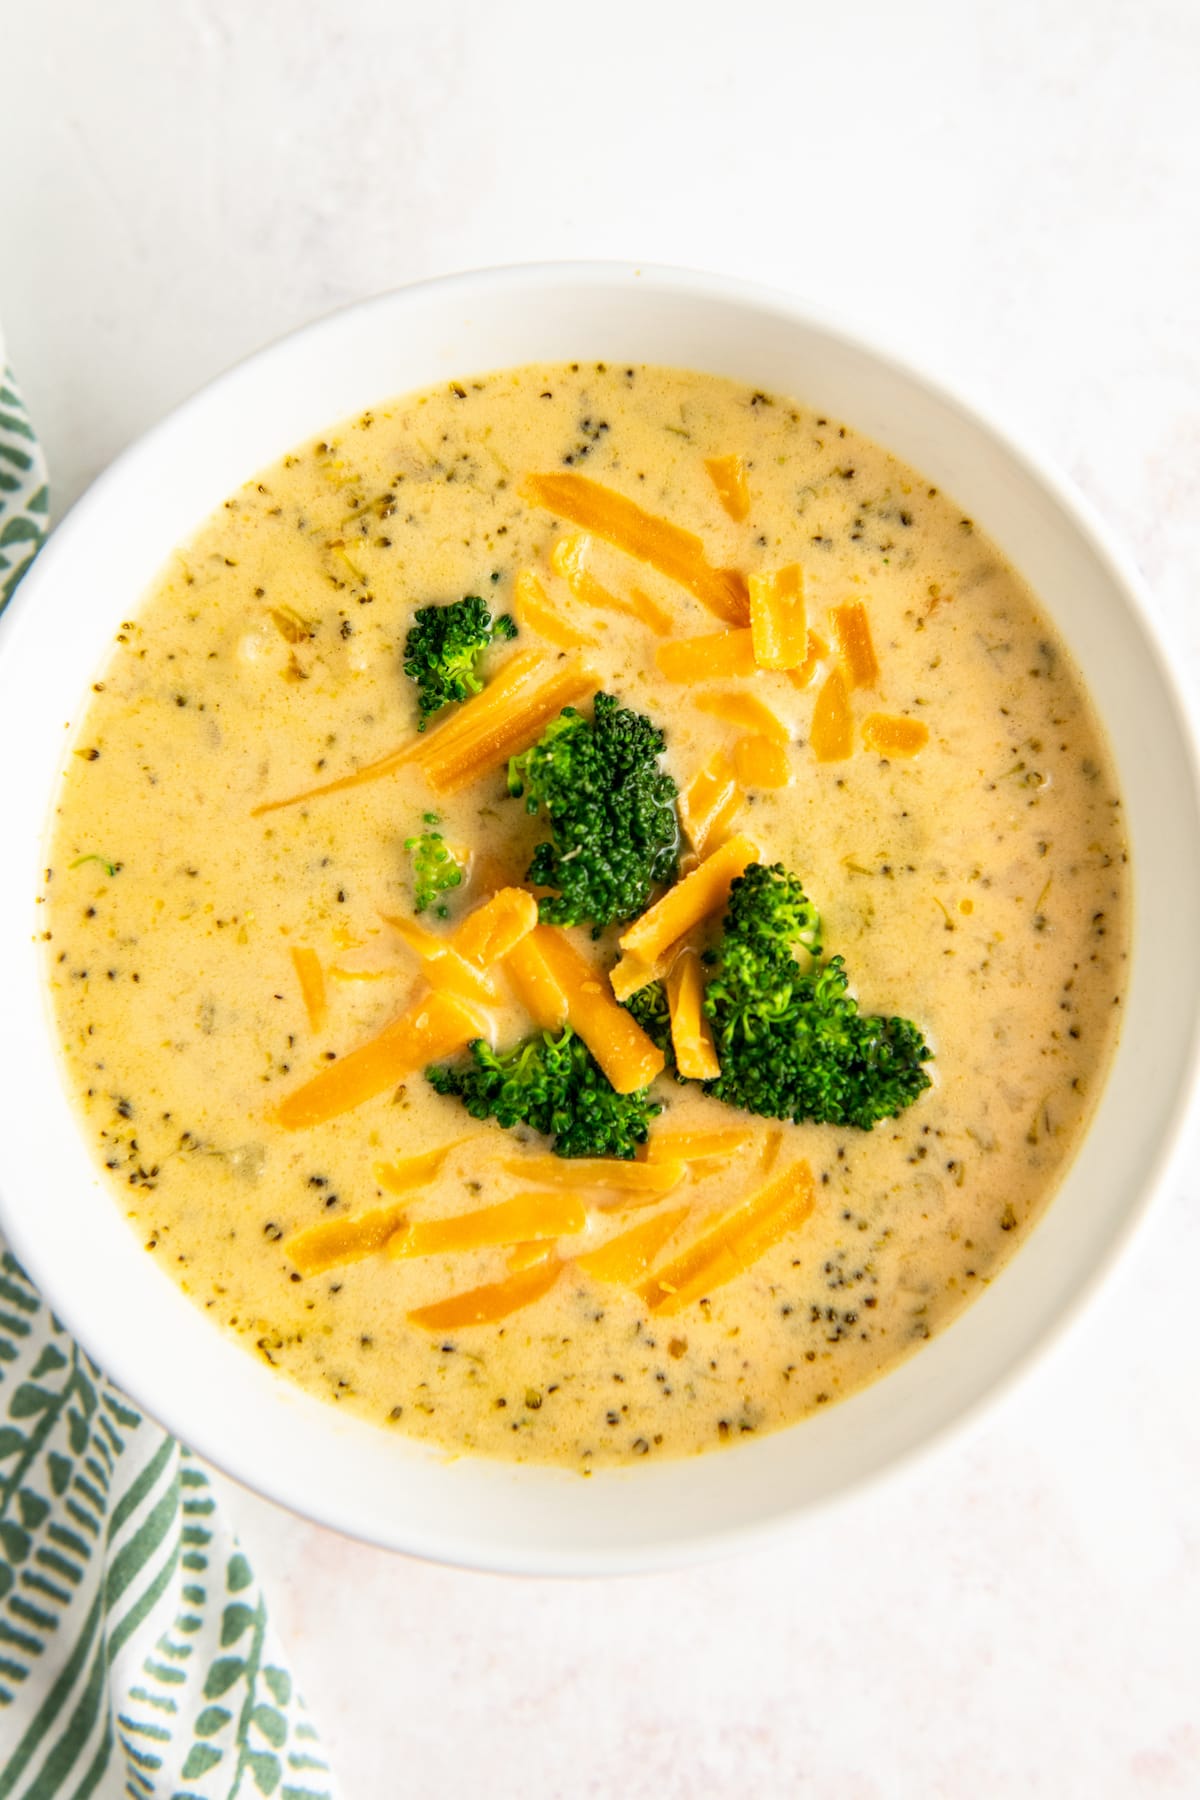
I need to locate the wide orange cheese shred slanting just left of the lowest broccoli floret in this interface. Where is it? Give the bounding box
[275,992,480,1130]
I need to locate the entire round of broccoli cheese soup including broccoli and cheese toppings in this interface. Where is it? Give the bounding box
[43,364,1130,1471]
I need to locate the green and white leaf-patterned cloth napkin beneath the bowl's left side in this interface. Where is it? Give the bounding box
[0,342,335,1800]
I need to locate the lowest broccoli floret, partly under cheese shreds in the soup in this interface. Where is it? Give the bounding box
[425,1026,662,1161]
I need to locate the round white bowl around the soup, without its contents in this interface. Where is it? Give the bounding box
[0,265,1200,1573]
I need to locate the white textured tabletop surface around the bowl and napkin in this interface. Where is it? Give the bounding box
[0,0,1200,1800]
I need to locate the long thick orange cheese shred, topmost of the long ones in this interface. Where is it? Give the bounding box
[524,470,750,625]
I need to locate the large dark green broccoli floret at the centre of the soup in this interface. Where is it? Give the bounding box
[509,693,678,936]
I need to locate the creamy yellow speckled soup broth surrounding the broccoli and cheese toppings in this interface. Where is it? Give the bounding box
[45,364,1128,1469]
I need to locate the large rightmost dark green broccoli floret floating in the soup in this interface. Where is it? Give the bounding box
[703,864,932,1130]
